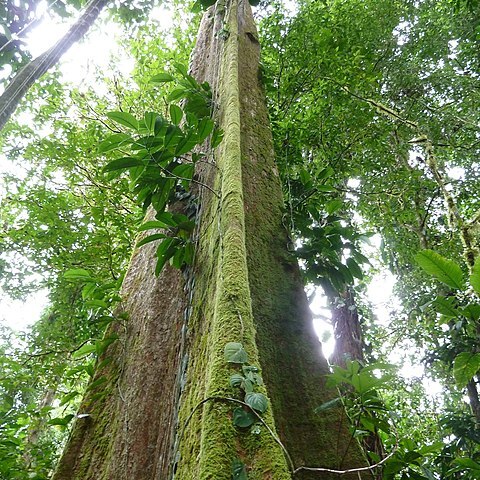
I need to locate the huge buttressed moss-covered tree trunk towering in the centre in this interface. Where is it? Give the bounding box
[50,0,362,480]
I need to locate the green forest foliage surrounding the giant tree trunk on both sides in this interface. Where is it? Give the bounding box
[0,0,480,480]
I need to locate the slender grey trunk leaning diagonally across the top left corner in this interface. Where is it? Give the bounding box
[0,0,108,130]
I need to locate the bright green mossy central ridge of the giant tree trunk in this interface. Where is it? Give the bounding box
[176,1,290,480]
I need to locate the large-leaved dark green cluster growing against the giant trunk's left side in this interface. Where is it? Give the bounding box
[98,64,222,275]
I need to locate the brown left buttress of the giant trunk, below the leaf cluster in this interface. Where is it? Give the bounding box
[53,245,188,480]
